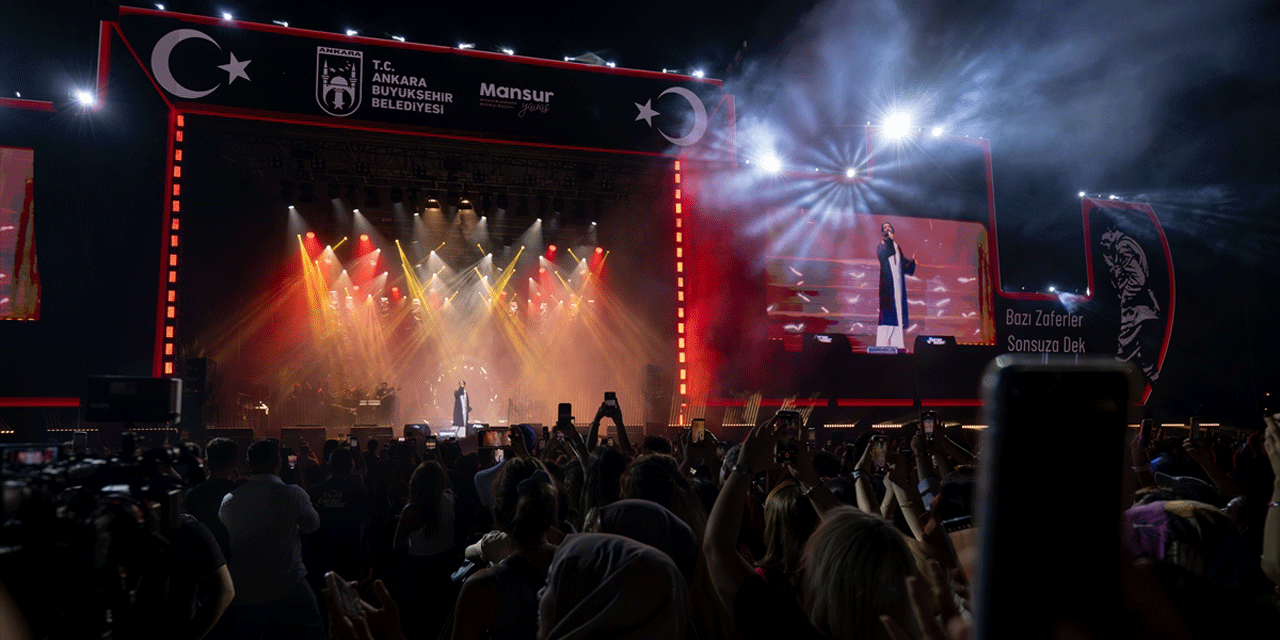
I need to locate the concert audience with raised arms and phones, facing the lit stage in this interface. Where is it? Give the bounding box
[2,403,1280,640]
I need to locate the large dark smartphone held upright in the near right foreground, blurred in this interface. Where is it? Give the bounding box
[972,355,1140,639]
